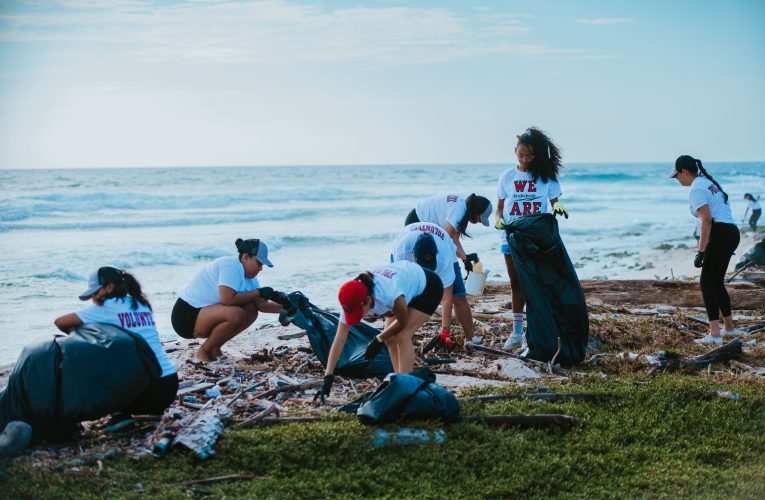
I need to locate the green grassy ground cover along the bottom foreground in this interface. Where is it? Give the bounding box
[0,374,765,498]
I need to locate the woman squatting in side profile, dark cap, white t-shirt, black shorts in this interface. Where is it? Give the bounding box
[172,238,281,361]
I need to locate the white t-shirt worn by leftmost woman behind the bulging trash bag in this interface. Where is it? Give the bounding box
[75,297,176,377]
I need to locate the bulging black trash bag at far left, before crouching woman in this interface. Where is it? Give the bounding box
[0,323,162,441]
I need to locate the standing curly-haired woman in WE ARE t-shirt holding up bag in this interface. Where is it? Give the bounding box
[494,127,568,350]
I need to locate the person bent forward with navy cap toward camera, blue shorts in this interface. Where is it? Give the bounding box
[391,222,481,349]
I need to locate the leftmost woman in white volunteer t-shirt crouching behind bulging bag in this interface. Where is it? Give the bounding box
[55,266,178,415]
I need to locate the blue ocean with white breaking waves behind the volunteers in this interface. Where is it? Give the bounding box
[0,162,765,364]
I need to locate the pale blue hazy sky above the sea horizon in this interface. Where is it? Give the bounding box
[0,0,765,168]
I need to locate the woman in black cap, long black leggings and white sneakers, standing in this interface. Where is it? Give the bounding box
[671,155,741,344]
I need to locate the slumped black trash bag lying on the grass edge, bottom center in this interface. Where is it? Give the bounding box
[356,368,462,425]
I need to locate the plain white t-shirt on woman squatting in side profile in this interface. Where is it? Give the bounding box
[180,256,260,307]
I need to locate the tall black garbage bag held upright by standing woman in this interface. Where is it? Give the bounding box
[506,214,590,366]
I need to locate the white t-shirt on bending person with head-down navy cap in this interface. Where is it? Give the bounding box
[391,222,457,287]
